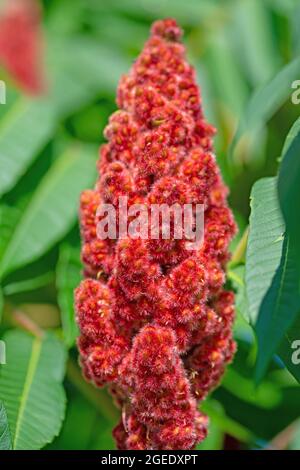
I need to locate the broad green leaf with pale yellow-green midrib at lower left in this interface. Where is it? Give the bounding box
[0,330,66,450]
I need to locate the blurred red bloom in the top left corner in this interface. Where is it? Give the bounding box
[0,0,45,95]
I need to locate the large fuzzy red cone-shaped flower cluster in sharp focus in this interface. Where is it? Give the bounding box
[75,19,235,449]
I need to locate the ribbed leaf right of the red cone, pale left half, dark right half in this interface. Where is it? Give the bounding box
[246,178,300,381]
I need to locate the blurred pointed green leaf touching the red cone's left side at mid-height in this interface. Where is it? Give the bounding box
[0,145,96,276]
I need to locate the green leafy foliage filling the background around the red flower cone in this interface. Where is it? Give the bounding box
[0,0,300,449]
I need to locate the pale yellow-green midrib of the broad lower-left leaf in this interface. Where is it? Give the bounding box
[13,338,42,449]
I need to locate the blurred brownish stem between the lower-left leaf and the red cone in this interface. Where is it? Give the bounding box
[67,359,119,422]
